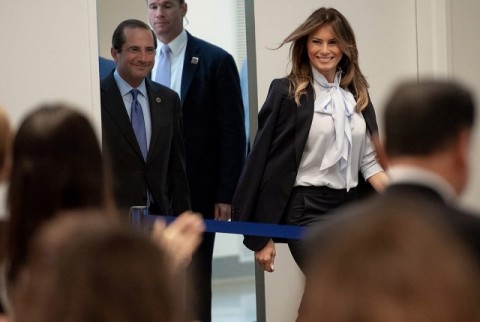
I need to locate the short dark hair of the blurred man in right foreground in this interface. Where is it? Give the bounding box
[384,80,475,157]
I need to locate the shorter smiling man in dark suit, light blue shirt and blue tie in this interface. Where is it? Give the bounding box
[100,19,190,219]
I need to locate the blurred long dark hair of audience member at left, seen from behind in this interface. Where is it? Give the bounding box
[7,103,114,281]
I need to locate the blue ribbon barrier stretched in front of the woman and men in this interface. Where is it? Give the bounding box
[130,208,305,239]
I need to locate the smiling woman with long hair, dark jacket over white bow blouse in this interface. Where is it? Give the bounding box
[232,8,388,272]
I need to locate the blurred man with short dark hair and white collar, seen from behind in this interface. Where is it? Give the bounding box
[364,79,480,260]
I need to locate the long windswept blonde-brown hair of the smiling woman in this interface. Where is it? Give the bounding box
[278,7,369,112]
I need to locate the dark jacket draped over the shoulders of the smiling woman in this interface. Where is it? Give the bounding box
[232,78,378,250]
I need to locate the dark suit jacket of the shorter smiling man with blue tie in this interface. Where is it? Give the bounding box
[100,72,190,215]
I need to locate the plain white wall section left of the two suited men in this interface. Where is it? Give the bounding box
[0,0,100,214]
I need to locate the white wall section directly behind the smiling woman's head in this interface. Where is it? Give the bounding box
[255,0,417,132]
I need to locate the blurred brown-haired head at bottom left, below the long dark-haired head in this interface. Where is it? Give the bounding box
[13,211,181,322]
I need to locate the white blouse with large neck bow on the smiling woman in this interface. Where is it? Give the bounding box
[295,68,382,190]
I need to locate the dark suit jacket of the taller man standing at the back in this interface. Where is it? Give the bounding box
[181,33,245,218]
